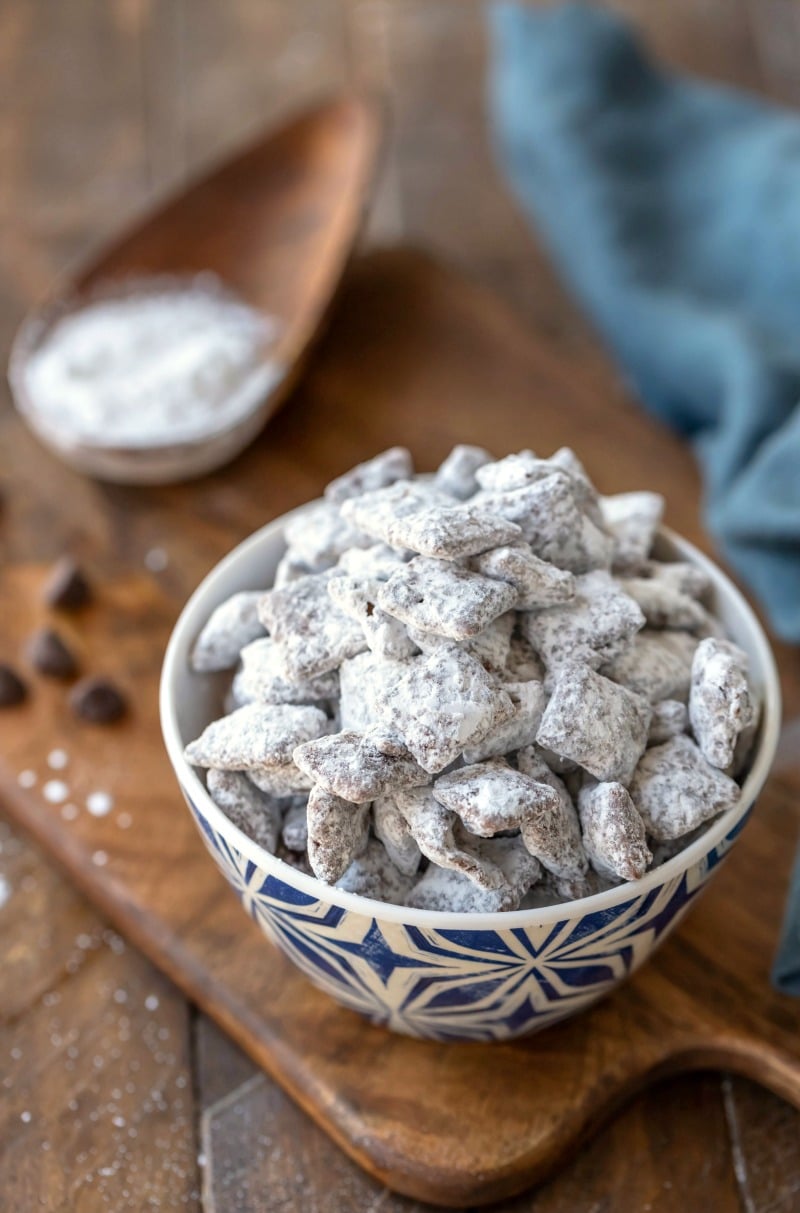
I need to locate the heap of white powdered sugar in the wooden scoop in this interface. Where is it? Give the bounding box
[25,273,280,448]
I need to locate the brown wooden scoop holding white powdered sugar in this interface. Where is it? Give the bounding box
[10,96,382,483]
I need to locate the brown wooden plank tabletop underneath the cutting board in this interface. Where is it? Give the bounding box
[0,0,800,1213]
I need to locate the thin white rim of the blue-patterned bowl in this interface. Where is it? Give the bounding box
[159,511,781,932]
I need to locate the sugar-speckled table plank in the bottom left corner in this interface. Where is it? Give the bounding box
[0,822,200,1213]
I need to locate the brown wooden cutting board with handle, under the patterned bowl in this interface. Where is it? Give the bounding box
[0,251,800,1206]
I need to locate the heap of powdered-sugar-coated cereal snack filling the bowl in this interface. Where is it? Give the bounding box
[185,446,759,913]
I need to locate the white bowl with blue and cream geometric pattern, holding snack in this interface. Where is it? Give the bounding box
[161,502,781,1041]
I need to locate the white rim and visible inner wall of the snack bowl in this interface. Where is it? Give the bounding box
[161,507,781,930]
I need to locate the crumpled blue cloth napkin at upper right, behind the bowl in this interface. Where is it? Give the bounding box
[490,4,800,642]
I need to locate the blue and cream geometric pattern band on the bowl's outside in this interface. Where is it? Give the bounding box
[187,797,747,1041]
